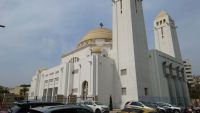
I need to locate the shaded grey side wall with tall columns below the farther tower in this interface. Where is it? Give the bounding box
[149,50,190,106]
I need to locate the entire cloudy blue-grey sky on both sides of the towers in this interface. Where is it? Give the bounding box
[0,0,200,87]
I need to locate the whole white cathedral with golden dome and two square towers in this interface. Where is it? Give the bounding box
[29,0,190,108]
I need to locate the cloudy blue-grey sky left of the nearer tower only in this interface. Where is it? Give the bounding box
[0,0,112,86]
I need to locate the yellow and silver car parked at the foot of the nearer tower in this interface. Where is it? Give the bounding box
[124,101,157,113]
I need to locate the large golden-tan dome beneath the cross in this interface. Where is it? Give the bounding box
[78,28,112,47]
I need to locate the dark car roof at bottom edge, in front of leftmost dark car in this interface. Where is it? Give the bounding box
[28,105,94,113]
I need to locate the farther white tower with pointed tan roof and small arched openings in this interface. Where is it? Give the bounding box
[154,11,182,60]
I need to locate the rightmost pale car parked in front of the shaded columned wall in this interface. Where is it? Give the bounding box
[156,102,181,113]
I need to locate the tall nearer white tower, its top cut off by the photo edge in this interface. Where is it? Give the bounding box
[113,0,151,106]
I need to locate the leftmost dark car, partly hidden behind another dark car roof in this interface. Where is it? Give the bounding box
[8,101,64,113]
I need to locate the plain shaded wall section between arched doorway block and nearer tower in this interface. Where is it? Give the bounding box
[96,55,113,106]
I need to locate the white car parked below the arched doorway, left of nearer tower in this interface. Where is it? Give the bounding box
[83,100,109,113]
